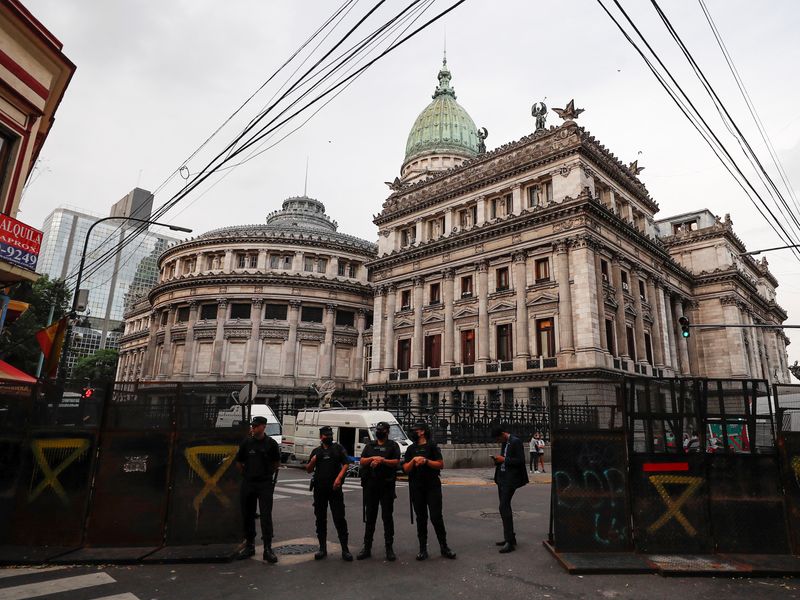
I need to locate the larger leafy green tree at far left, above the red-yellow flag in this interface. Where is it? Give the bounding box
[0,275,72,375]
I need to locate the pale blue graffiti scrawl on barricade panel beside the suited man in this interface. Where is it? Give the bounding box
[553,467,628,545]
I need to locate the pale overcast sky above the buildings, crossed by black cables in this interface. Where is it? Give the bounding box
[19,0,800,362]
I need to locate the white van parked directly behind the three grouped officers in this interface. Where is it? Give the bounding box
[281,408,411,462]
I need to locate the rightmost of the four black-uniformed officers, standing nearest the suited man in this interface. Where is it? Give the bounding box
[403,421,456,560]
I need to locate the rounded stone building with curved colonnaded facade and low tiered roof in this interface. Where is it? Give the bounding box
[118,197,375,395]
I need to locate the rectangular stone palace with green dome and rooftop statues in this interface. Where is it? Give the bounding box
[366,64,789,404]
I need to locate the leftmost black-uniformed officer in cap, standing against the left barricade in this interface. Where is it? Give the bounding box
[236,417,281,563]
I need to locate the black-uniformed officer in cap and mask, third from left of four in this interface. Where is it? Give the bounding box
[356,421,400,561]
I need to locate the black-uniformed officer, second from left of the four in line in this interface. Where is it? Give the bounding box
[306,426,353,561]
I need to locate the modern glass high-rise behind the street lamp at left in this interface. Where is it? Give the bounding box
[37,188,177,371]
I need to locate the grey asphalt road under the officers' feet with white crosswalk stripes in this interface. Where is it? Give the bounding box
[0,469,800,600]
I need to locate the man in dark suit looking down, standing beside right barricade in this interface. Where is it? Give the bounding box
[492,423,528,554]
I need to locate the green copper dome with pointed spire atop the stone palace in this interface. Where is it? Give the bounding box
[404,59,478,163]
